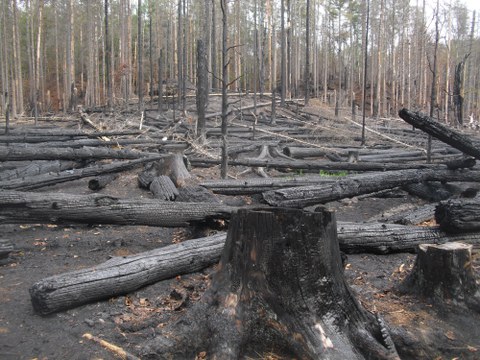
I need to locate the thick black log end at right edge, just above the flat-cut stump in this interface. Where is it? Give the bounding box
[435,197,480,233]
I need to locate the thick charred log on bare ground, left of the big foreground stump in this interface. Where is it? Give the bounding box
[30,234,225,315]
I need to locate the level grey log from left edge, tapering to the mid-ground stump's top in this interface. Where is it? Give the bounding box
[0,146,156,161]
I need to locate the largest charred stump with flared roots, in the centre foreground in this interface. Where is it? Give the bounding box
[142,209,398,360]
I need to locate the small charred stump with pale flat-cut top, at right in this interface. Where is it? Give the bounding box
[400,242,480,311]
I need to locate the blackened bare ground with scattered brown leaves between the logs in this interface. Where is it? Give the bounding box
[0,99,480,360]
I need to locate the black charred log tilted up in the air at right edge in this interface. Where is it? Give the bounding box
[398,109,480,159]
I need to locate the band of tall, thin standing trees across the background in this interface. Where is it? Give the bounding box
[0,0,480,123]
